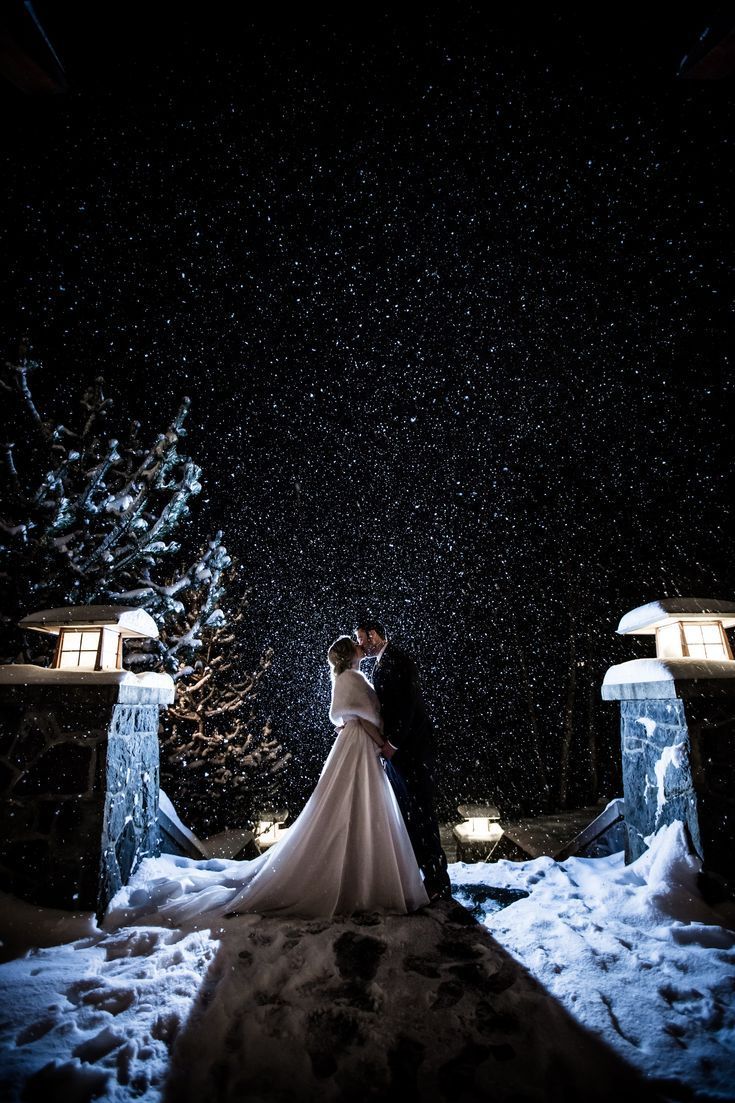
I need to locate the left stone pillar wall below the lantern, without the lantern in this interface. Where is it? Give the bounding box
[0,685,159,914]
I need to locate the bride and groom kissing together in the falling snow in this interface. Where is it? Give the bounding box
[212,621,450,917]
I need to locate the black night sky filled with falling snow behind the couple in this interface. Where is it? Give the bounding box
[0,3,735,812]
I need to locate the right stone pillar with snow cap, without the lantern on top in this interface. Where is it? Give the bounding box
[603,660,735,890]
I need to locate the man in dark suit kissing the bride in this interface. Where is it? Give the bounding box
[354,621,451,900]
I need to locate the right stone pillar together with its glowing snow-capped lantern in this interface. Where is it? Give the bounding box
[603,598,735,892]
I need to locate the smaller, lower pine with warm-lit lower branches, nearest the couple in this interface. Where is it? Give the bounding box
[109,532,290,837]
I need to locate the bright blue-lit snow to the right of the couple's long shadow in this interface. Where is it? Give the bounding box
[450,822,735,1099]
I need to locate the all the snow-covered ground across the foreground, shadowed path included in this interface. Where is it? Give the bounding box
[0,824,735,1103]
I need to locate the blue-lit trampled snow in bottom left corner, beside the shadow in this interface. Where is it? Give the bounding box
[0,928,217,1103]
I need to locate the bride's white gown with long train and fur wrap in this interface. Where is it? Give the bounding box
[130,670,428,922]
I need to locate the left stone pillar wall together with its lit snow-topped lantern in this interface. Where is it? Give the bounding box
[0,606,174,914]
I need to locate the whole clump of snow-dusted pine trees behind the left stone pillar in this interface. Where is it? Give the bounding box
[0,347,288,831]
